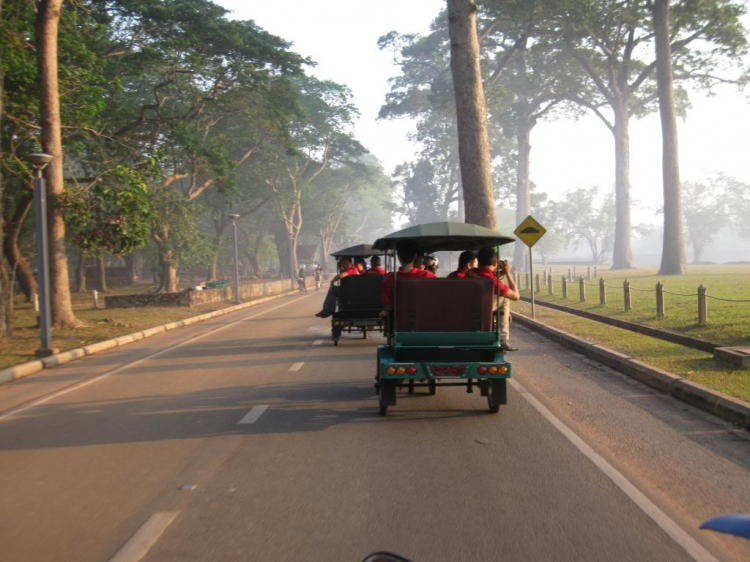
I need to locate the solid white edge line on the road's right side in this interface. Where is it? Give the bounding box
[508,379,718,562]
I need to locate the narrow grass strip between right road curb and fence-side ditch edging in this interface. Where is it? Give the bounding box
[511,302,750,402]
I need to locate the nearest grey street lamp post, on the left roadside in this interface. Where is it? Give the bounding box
[26,152,57,357]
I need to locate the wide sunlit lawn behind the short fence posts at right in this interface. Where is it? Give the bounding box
[522,265,750,346]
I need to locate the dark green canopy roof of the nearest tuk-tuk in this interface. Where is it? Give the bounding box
[373,222,516,252]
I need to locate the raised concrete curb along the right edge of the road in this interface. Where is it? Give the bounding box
[513,312,750,429]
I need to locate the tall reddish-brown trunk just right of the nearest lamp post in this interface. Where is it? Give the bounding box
[36,0,78,328]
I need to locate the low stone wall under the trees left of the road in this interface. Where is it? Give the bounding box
[104,276,315,308]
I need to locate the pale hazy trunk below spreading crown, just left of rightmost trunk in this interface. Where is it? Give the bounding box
[612,101,633,269]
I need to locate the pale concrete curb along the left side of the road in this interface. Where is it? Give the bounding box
[0,290,299,384]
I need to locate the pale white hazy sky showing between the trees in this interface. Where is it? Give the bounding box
[216,0,750,222]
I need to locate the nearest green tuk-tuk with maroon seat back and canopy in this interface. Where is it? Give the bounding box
[373,222,515,416]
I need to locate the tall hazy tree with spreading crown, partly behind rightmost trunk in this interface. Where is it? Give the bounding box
[553,0,747,269]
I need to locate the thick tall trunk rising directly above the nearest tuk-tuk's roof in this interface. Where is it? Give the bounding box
[448,0,497,229]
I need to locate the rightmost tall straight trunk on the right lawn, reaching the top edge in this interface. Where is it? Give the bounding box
[653,0,686,275]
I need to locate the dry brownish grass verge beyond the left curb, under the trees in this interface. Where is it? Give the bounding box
[0,287,238,369]
